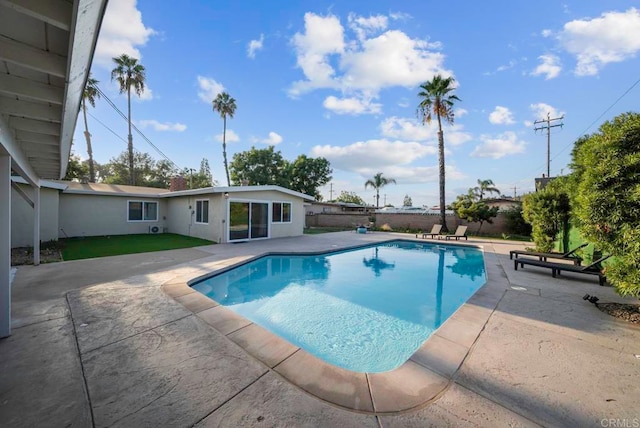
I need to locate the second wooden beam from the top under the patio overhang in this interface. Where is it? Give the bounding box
[0,36,67,78]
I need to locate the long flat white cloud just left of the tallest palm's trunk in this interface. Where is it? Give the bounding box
[311,139,437,172]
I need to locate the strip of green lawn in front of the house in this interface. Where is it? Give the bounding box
[61,233,215,260]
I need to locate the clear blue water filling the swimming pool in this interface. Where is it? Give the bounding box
[193,241,486,373]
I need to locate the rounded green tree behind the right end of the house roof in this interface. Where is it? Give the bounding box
[287,155,333,200]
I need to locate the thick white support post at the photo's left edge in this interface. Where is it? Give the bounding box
[0,156,11,338]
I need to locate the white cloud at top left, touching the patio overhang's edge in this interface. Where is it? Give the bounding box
[94,0,157,70]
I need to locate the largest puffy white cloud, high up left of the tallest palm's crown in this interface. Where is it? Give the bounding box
[289,13,452,108]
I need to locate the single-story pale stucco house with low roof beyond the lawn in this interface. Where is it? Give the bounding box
[11,177,313,247]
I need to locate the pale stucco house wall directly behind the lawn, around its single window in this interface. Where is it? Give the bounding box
[59,193,167,238]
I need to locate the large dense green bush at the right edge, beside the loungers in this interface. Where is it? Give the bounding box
[572,113,640,297]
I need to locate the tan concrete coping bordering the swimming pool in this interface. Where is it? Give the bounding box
[161,237,509,415]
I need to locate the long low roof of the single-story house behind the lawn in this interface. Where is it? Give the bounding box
[57,181,314,201]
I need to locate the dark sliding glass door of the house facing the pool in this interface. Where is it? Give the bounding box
[229,201,269,241]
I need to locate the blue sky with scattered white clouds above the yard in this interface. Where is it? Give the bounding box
[73,0,640,206]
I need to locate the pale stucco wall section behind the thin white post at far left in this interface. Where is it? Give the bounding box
[11,184,59,248]
